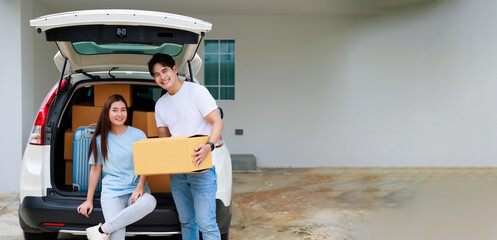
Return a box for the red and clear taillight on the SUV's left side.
[29,78,66,145]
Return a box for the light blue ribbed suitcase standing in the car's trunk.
[72,125,102,192]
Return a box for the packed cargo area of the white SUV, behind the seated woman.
[52,79,175,196]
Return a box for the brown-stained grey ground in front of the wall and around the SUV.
[0,168,497,240]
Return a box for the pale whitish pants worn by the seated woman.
[102,193,157,240]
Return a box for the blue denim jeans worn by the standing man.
[169,168,221,240]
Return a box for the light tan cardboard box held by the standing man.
[133,135,212,175]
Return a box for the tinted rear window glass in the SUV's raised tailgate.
[72,42,183,57]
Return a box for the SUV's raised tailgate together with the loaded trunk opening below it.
[30,10,212,197]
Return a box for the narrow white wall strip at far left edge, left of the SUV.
[0,1,22,191]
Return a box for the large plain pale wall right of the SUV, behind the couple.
[201,0,497,167]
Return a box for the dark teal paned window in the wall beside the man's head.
[204,40,235,100]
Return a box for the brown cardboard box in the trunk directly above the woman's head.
[93,84,132,107]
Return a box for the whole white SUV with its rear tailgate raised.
[19,10,232,239]
